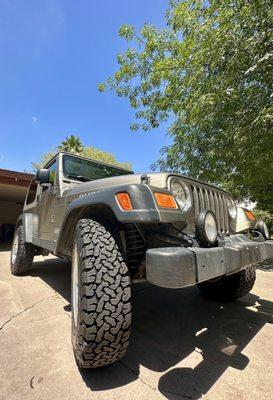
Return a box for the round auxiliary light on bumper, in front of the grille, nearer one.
[196,210,218,245]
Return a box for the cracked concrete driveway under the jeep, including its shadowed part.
[0,252,273,400]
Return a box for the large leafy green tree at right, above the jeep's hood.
[99,0,273,211]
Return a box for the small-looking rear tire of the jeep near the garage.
[10,225,35,275]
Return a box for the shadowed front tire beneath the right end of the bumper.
[197,265,256,301]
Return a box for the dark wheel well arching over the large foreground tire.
[56,204,119,256]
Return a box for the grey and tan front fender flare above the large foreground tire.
[56,184,186,254]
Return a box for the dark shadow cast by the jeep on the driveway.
[29,259,273,400]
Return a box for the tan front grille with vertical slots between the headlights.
[191,185,229,233]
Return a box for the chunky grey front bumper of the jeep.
[146,234,273,288]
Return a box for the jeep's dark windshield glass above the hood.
[63,156,133,181]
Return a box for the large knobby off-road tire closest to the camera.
[71,219,131,368]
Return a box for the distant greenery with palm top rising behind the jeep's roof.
[32,135,132,171]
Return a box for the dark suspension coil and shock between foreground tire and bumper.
[125,225,146,274]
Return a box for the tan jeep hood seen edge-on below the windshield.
[67,173,170,195]
